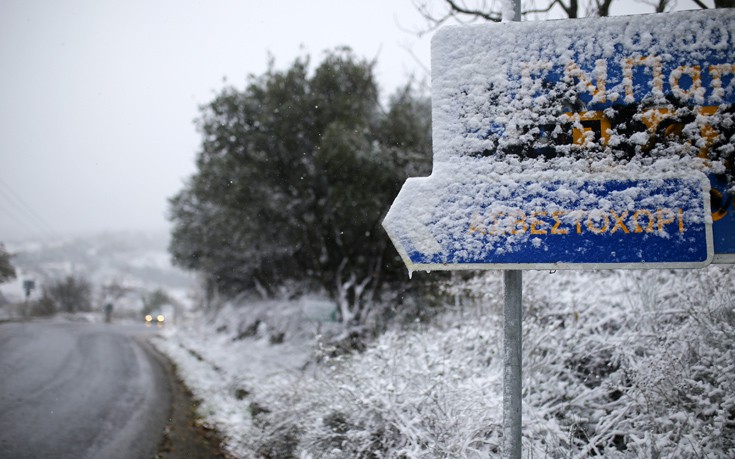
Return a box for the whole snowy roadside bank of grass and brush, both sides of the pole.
[155,266,735,458]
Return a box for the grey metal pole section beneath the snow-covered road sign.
[503,270,523,459]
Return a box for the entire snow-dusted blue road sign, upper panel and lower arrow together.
[383,9,735,270]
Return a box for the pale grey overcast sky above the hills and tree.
[0,0,708,242]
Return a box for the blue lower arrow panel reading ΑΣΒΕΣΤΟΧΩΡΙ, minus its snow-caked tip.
[392,178,712,270]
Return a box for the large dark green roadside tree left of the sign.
[170,49,431,322]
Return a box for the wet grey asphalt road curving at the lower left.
[0,322,171,459]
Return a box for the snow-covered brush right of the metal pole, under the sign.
[524,268,735,458]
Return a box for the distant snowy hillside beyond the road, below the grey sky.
[0,232,198,317]
